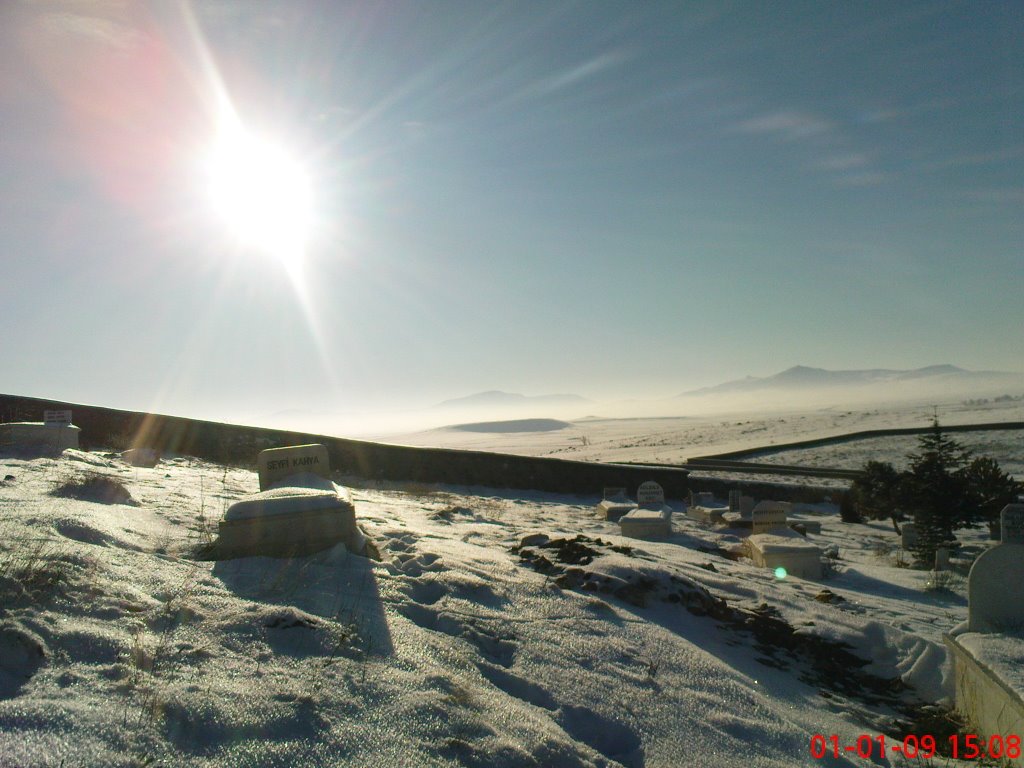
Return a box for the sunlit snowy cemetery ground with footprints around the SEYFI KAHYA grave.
[0,451,982,768]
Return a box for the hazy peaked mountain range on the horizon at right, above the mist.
[678,364,1020,397]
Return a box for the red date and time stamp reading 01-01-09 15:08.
[811,733,1022,760]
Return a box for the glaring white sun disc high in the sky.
[201,124,313,265]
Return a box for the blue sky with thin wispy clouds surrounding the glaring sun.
[0,0,1024,428]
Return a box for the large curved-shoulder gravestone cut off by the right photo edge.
[967,504,1024,632]
